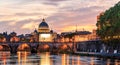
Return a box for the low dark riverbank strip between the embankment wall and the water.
[74,52,120,59]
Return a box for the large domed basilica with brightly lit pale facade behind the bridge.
[31,19,57,42]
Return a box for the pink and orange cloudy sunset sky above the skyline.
[0,0,119,34]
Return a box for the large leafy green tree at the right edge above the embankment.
[96,2,120,44]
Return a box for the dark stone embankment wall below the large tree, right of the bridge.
[76,42,120,53]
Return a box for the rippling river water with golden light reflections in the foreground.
[0,52,120,65]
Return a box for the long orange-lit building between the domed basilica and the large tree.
[57,30,99,42]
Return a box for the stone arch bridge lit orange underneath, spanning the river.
[0,42,74,53]
